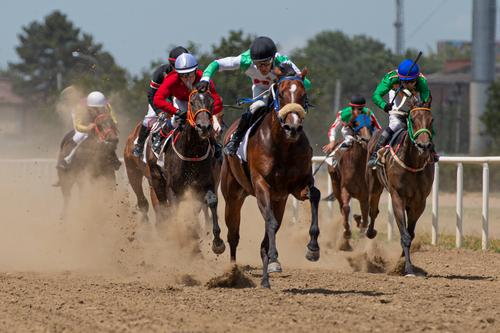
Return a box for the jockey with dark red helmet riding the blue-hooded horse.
[323,95,381,154]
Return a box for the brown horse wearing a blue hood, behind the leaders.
[328,114,373,251]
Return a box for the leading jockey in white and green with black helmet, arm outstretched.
[197,37,311,155]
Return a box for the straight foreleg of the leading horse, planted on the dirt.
[255,177,279,288]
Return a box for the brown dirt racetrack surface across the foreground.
[0,245,500,332]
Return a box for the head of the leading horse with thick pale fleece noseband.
[273,63,307,141]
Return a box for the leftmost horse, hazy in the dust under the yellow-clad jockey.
[57,112,118,217]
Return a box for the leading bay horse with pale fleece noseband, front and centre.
[221,64,321,288]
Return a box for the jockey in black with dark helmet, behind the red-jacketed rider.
[133,46,189,157]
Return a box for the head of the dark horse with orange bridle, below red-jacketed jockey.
[187,90,214,139]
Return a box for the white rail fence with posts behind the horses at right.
[312,156,500,250]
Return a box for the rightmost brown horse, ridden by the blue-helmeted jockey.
[366,98,434,276]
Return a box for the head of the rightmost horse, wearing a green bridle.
[407,99,434,153]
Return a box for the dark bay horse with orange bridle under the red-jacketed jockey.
[146,90,225,254]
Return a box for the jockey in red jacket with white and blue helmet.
[153,53,222,154]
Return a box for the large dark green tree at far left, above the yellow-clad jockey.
[9,11,127,102]
